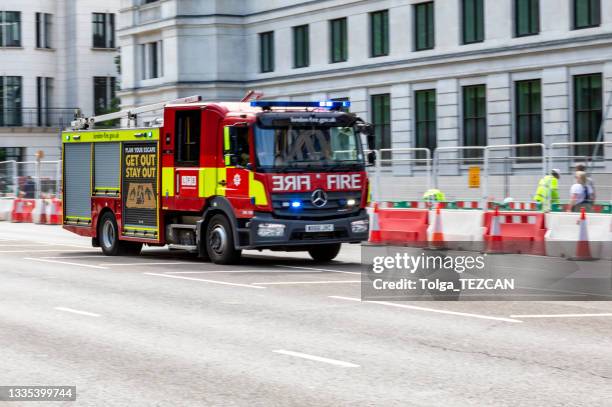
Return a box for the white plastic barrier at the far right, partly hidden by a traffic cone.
[546,212,612,260]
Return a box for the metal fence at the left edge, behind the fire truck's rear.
[0,161,62,199]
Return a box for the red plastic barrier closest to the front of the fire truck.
[371,208,429,245]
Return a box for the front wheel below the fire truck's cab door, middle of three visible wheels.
[206,215,241,264]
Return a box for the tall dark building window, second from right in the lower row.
[516,79,542,156]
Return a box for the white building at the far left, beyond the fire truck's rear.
[0,0,119,162]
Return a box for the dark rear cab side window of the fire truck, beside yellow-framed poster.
[174,110,201,166]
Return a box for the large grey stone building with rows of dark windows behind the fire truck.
[119,0,612,178]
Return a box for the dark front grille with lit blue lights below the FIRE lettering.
[272,191,361,220]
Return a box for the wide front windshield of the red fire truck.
[254,126,364,172]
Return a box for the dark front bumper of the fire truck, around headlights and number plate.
[242,210,369,249]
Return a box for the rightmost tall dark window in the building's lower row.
[574,74,603,156]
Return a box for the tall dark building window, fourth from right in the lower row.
[414,89,437,159]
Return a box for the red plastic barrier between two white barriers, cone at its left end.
[484,211,546,256]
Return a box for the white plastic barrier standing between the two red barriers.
[427,209,485,242]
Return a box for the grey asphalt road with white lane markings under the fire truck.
[0,222,612,406]
